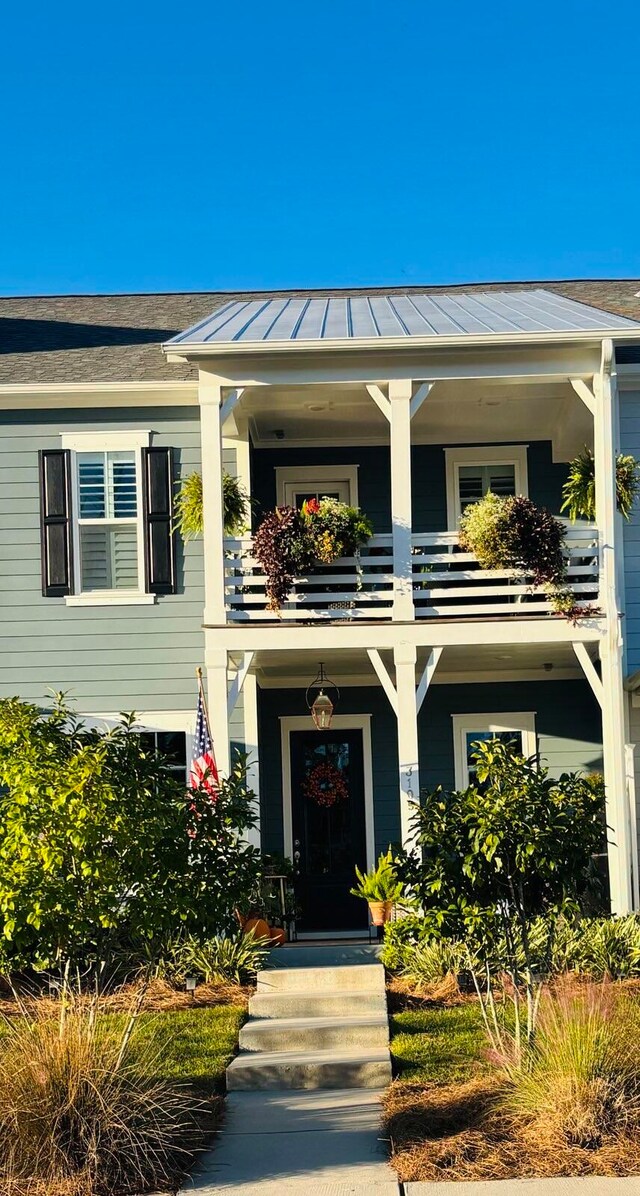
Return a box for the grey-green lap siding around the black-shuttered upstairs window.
[0,407,205,713]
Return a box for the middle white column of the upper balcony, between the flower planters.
[389,378,415,622]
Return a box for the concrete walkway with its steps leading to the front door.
[183,946,398,1196]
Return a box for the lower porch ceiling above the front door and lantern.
[251,643,597,688]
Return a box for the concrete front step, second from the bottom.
[240,1012,389,1051]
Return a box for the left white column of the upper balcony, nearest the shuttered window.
[199,370,225,626]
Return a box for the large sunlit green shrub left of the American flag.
[0,698,260,970]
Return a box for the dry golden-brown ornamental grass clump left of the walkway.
[0,994,202,1196]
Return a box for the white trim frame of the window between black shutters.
[60,429,156,606]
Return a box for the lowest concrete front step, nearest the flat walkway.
[226,1048,391,1092]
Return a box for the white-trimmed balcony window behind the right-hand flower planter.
[445,445,529,531]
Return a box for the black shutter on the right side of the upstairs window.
[142,449,176,594]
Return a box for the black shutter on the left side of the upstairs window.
[39,449,73,598]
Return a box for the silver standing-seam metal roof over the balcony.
[166,288,640,350]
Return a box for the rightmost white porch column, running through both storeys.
[593,340,635,914]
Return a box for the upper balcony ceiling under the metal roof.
[242,379,592,453]
